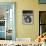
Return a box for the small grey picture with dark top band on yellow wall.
[22,10,33,24]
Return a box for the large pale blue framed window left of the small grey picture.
[0,2,16,40]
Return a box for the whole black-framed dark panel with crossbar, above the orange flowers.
[39,11,46,35]
